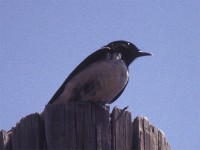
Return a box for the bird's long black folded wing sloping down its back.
[48,47,108,104]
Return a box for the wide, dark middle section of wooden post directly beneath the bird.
[44,102,111,150]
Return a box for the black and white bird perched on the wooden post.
[48,41,152,105]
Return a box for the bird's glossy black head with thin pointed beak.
[105,41,152,66]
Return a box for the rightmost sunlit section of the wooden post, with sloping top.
[133,116,171,150]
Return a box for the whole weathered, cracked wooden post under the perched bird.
[0,102,170,150]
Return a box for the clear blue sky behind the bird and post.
[0,0,200,150]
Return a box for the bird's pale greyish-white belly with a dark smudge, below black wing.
[56,59,128,103]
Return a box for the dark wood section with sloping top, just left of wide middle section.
[12,113,44,150]
